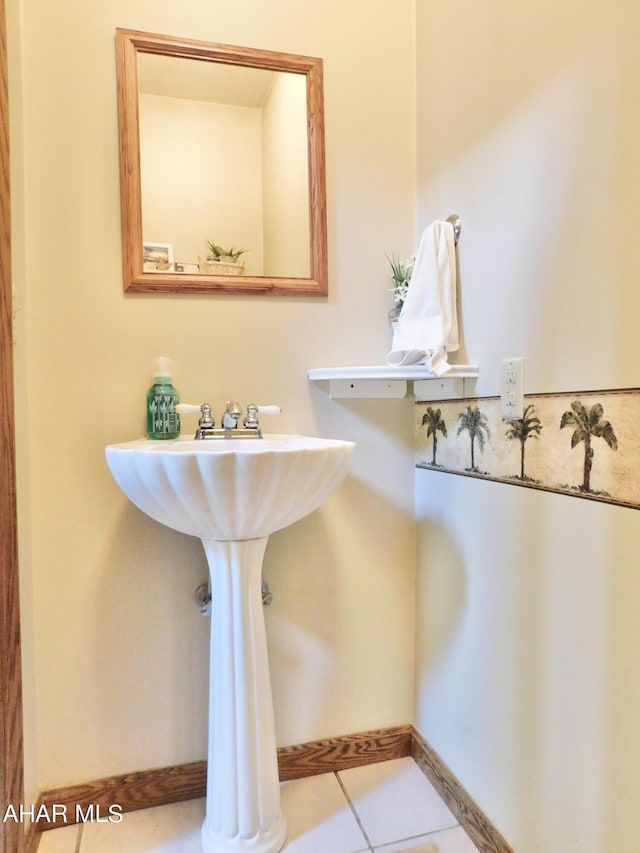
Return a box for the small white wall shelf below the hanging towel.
[307,364,478,400]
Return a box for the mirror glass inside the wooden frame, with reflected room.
[138,53,311,278]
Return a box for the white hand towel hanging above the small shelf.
[387,220,458,376]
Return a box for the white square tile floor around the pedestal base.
[38,758,477,853]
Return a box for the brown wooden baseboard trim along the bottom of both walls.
[30,725,514,853]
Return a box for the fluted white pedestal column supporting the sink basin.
[201,536,287,853]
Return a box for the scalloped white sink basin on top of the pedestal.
[106,435,354,540]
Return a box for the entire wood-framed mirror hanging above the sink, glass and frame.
[116,29,328,296]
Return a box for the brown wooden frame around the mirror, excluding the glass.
[116,29,328,296]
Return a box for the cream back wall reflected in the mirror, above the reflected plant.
[138,93,263,275]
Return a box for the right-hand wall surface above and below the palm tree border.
[416,0,640,853]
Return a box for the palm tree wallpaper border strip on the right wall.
[416,388,640,509]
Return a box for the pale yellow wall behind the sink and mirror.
[10,0,415,791]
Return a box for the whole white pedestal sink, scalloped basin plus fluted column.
[106,435,355,853]
